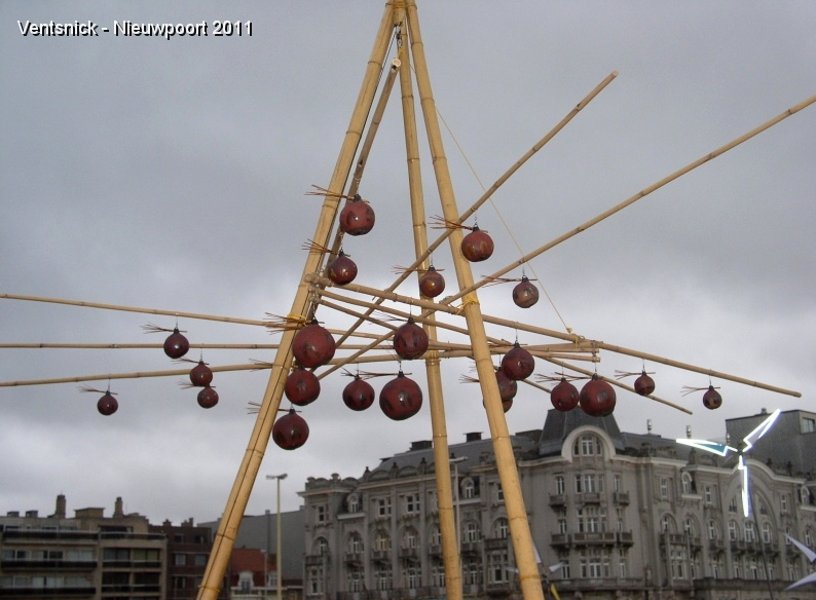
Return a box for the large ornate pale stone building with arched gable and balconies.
[302,410,816,600]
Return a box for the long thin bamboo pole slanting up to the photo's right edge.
[450,95,816,304]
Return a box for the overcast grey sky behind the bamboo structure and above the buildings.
[0,0,816,522]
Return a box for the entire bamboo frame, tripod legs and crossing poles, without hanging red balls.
[0,0,816,600]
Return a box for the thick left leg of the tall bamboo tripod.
[198,2,400,600]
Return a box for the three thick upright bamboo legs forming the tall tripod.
[198,0,544,600]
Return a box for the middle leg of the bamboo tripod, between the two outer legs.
[398,11,463,600]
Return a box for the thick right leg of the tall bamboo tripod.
[406,0,544,600]
